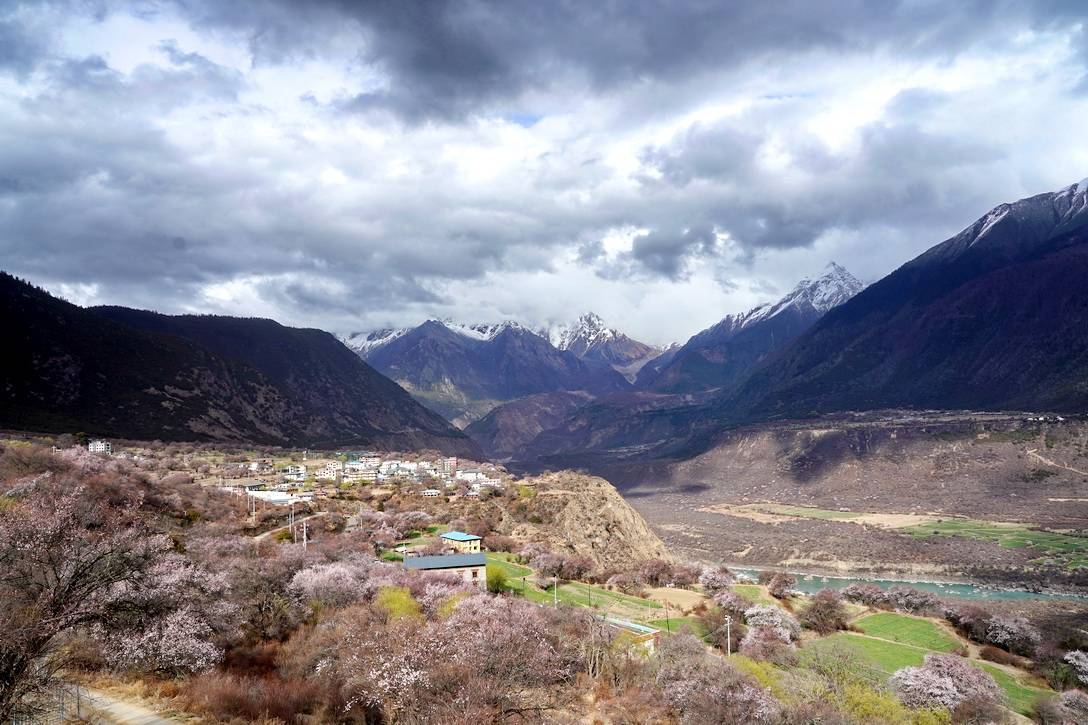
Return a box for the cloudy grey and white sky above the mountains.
[0,0,1088,343]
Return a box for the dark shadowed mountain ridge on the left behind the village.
[0,273,480,457]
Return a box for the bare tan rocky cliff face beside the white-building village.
[507,471,672,569]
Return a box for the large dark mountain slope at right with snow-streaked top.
[730,183,1088,419]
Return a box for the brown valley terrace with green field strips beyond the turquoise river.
[613,413,1088,587]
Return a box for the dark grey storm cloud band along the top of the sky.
[165,0,1088,120]
